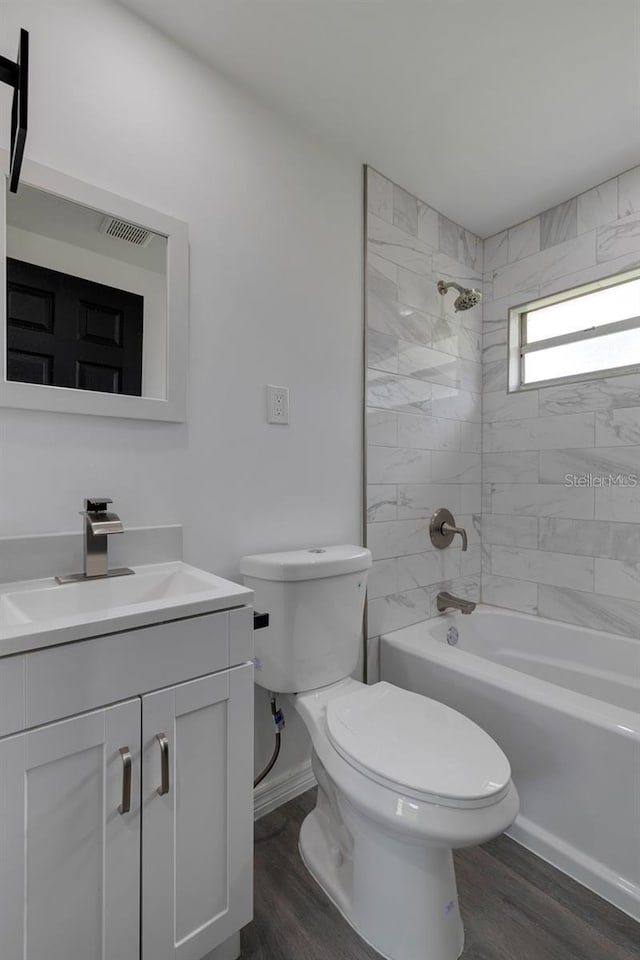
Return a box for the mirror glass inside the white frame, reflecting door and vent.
[6,185,167,400]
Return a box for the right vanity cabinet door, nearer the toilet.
[142,664,253,960]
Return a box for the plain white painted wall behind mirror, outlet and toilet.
[0,0,362,774]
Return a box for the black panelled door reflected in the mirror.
[7,258,144,397]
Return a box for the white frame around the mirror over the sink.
[0,150,189,422]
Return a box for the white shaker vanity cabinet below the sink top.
[0,607,253,960]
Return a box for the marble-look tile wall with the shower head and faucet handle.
[366,168,480,660]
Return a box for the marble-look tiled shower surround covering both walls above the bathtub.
[366,167,640,638]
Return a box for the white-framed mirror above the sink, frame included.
[0,152,188,420]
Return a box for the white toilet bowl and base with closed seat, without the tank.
[291,680,518,960]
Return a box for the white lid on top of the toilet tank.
[240,544,371,581]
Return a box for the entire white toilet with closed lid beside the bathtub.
[240,545,518,960]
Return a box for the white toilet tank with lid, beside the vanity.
[240,545,371,693]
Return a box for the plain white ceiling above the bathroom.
[120,0,640,237]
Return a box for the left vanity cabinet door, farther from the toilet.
[0,700,140,960]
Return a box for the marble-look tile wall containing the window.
[481,167,640,638]
